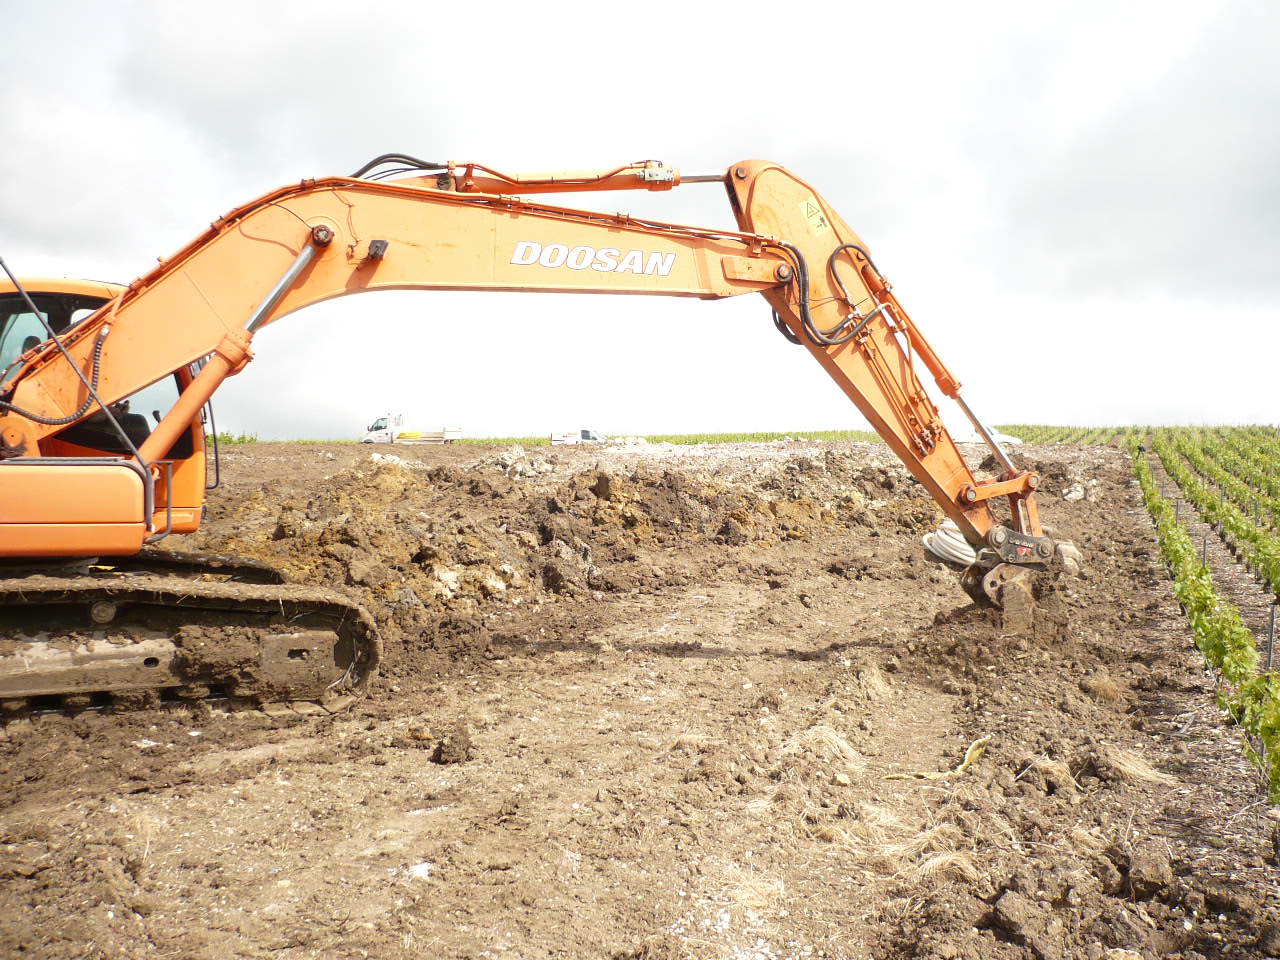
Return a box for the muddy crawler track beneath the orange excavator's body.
[0,575,380,716]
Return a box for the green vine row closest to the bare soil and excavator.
[1129,438,1280,804]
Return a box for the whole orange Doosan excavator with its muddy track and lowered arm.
[0,154,1059,710]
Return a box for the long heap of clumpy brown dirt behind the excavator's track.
[214,447,901,676]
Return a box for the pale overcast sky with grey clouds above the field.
[0,0,1280,438]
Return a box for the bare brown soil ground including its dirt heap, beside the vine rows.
[0,443,1280,960]
